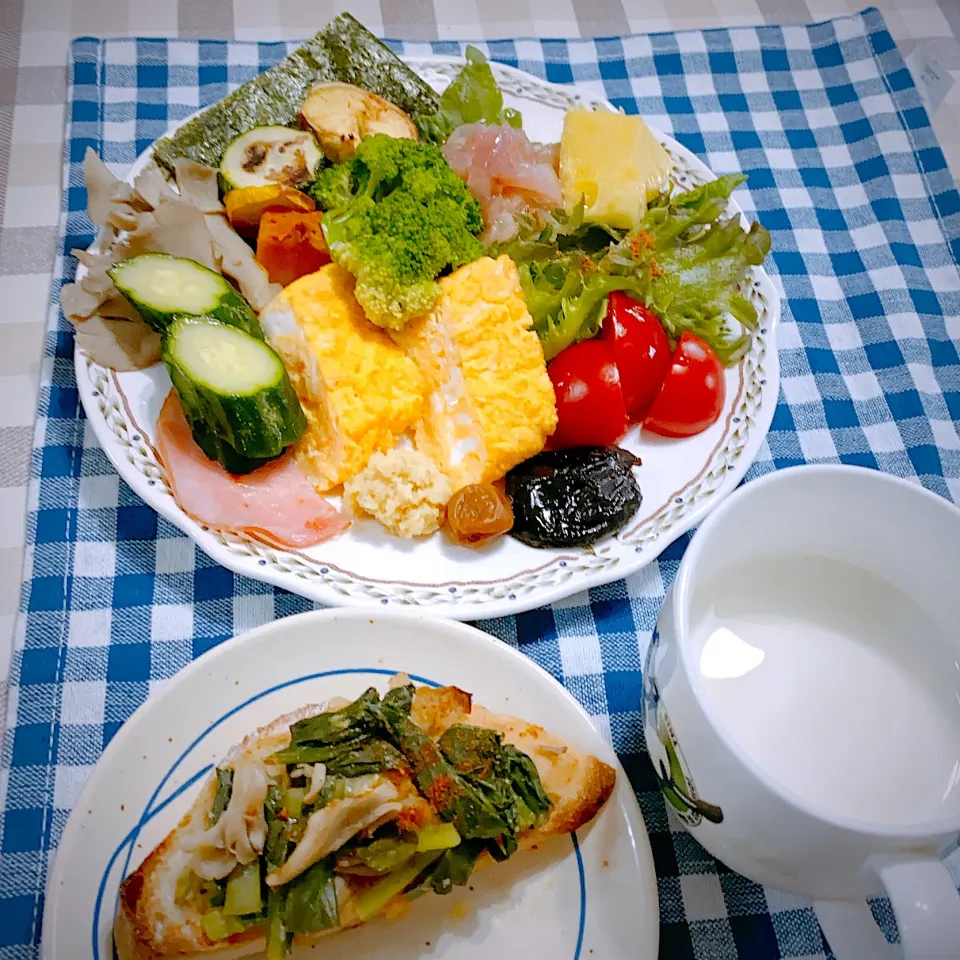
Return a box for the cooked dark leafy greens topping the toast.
[178,685,551,960]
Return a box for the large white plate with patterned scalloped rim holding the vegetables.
[75,57,780,620]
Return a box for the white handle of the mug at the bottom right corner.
[813,855,960,960]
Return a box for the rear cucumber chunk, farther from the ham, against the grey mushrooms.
[108,253,263,340]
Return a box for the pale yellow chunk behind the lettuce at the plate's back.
[560,109,671,230]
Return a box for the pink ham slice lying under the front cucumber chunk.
[157,390,350,547]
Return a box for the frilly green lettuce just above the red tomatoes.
[493,174,770,365]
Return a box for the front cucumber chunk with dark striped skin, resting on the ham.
[163,317,307,473]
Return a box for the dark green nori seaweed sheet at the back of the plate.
[153,13,440,170]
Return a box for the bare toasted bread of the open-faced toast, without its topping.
[114,687,616,960]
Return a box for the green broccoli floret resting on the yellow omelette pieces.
[310,134,483,330]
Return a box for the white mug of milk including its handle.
[643,465,960,960]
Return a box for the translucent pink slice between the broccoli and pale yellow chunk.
[443,123,563,244]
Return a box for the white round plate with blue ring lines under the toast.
[41,610,659,960]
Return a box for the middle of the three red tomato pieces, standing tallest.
[600,290,670,414]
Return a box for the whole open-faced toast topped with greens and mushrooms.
[114,679,615,960]
